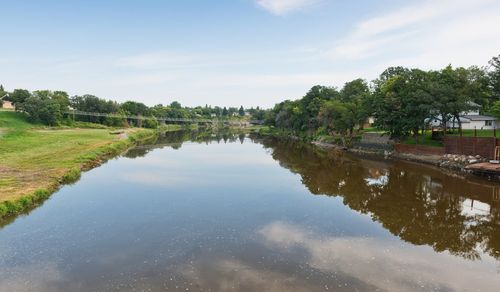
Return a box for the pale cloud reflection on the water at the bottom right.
[259,221,500,291]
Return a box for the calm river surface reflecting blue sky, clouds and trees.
[0,132,500,292]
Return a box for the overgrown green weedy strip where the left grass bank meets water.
[0,129,161,221]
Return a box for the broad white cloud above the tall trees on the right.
[326,0,500,68]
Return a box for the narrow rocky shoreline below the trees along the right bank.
[254,130,480,177]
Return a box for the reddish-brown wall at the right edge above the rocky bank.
[444,136,497,159]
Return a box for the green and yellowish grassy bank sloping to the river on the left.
[0,111,180,218]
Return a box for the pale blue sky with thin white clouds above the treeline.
[0,0,500,108]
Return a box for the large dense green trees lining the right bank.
[266,55,500,138]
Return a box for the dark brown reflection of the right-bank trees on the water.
[259,138,500,260]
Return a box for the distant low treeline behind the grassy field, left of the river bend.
[0,85,264,128]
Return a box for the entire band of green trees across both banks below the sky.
[0,55,500,138]
